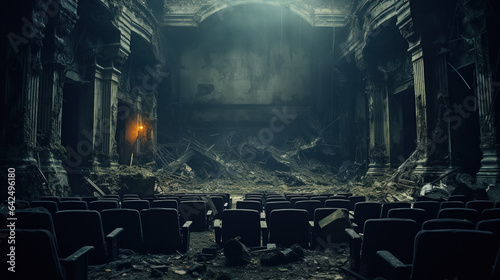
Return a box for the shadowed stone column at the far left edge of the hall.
[0,4,47,200]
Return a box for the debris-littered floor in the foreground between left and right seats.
[89,231,355,280]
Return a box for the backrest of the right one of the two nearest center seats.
[269,209,311,248]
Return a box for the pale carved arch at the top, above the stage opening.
[162,0,355,27]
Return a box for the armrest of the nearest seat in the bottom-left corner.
[60,246,94,280]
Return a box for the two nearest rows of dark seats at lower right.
[346,218,500,280]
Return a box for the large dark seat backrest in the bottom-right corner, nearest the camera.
[411,229,498,280]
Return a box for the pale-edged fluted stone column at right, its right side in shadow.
[397,1,449,180]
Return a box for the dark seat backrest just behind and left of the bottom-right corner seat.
[360,218,420,277]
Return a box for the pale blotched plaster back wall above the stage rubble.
[179,5,314,121]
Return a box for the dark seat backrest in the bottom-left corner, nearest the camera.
[0,229,64,280]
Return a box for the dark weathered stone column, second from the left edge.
[37,1,77,196]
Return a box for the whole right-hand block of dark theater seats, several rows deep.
[346,197,500,280]
